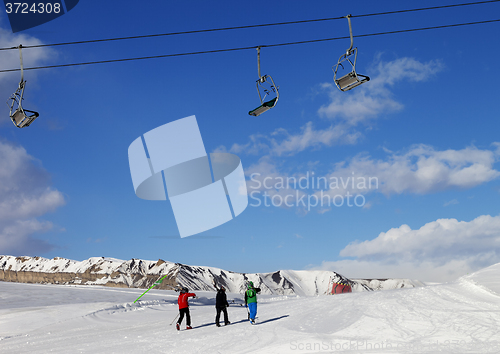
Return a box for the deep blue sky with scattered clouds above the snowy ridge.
[0,0,500,281]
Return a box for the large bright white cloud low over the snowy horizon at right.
[314,215,500,281]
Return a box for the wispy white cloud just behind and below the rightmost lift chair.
[318,58,443,125]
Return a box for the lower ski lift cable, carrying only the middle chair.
[0,18,500,73]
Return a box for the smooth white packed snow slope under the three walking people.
[0,264,500,354]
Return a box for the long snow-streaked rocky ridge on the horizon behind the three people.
[0,256,423,296]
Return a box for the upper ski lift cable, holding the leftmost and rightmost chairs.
[0,0,500,51]
